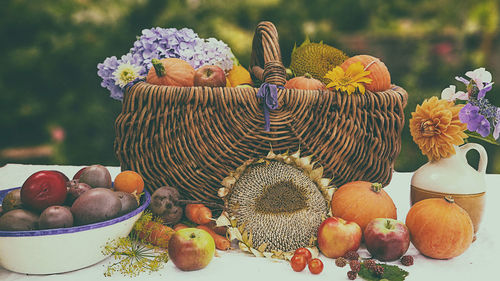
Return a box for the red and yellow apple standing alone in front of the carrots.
[168,228,215,271]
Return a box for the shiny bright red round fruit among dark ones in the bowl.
[21,171,67,211]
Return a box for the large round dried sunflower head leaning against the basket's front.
[219,152,333,257]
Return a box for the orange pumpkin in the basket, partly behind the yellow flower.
[341,55,391,92]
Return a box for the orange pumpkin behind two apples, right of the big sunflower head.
[331,181,397,232]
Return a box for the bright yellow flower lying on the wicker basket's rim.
[325,62,372,95]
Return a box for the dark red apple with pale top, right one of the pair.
[364,218,410,261]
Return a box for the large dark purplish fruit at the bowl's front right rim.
[71,187,122,225]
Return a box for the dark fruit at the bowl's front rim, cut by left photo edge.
[0,209,39,231]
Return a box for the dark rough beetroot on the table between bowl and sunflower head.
[149,186,183,224]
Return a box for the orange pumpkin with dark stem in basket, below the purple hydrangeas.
[146,58,195,87]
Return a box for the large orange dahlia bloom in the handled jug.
[410,97,467,161]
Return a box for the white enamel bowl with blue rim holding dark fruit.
[0,188,151,274]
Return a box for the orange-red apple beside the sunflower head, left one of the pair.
[318,217,362,258]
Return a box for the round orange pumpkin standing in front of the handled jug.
[406,197,474,259]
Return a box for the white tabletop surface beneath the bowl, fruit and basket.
[0,164,500,281]
